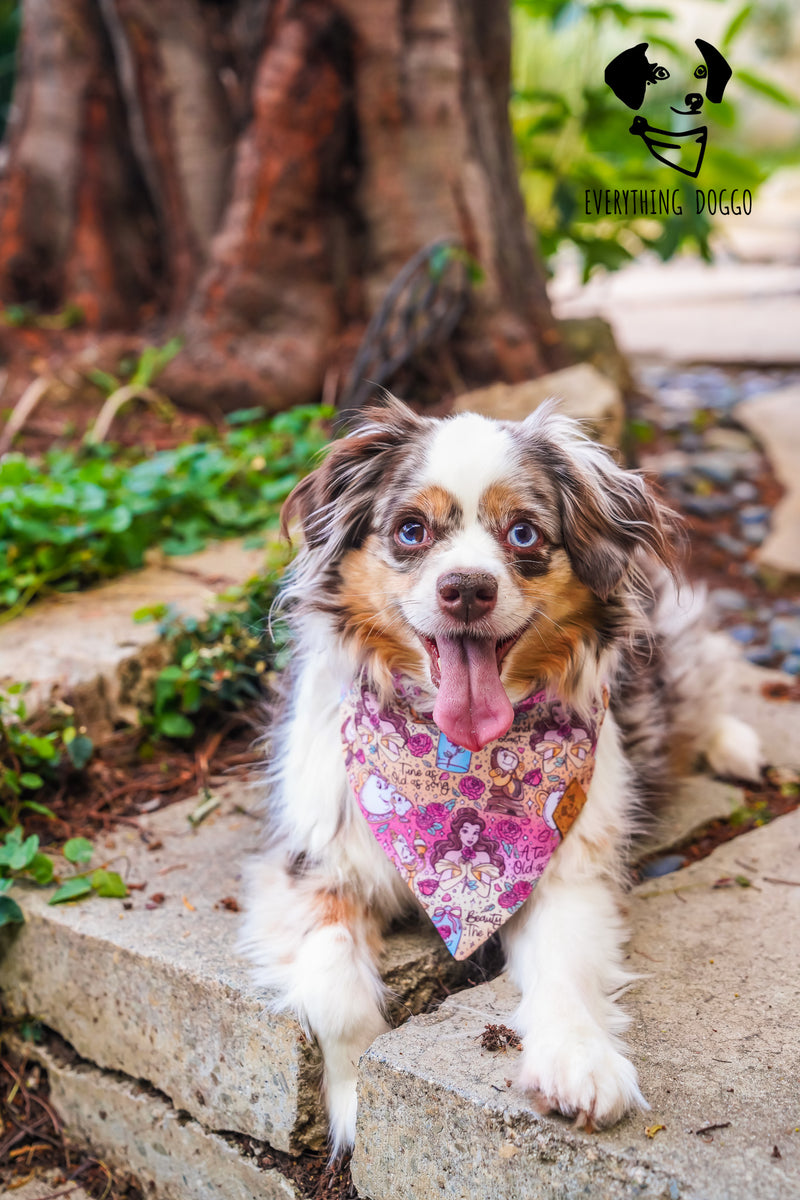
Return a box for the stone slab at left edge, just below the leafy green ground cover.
[0,540,272,732]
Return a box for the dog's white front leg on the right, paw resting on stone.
[504,714,646,1126]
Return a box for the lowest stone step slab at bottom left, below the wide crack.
[10,1043,300,1200]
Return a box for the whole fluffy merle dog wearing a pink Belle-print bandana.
[241,397,759,1152]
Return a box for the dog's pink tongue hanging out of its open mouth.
[433,637,513,750]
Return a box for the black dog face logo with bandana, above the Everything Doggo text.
[604,37,733,179]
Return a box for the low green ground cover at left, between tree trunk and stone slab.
[0,407,331,622]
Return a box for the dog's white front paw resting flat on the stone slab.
[518,1028,649,1129]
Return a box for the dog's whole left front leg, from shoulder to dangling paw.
[240,623,409,1151]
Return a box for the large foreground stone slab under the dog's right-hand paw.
[353,812,800,1200]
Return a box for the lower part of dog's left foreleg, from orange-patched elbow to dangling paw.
[242,858,389,1153]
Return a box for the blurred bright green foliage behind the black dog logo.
[510,0,798,278]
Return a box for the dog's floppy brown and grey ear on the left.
[281,392,428,558]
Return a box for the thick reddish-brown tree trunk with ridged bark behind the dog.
[0,0,565,408]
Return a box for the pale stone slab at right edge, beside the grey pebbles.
[734,386,800,578]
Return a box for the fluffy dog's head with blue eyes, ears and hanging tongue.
[284,400,674,749]
